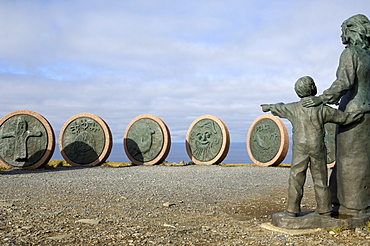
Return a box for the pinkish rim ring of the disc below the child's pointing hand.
[247,114,289,166]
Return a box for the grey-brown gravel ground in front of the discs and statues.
[0,165,370,245]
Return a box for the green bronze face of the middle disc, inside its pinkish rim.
[126,118,164,163]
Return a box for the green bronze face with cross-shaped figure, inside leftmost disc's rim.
[0,114,48,167]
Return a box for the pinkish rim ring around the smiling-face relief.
[185,115,230,165]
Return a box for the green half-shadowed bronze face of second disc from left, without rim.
[62,117,107,165]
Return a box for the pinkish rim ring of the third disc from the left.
[123,114,171,165]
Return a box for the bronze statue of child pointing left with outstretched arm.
[261,76,363,217]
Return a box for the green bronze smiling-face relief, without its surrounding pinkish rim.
[189,119,223,162]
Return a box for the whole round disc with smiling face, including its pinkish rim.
[186,115,230,165]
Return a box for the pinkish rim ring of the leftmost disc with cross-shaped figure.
[0,110,55,169]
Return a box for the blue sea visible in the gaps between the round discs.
[52,142,292,164]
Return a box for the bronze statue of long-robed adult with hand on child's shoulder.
[303,14,370,215]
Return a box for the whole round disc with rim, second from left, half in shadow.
[59,113,112,166]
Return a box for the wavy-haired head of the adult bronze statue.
[341,14,370,50]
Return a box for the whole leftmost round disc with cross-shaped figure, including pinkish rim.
[0,110,55,168]
